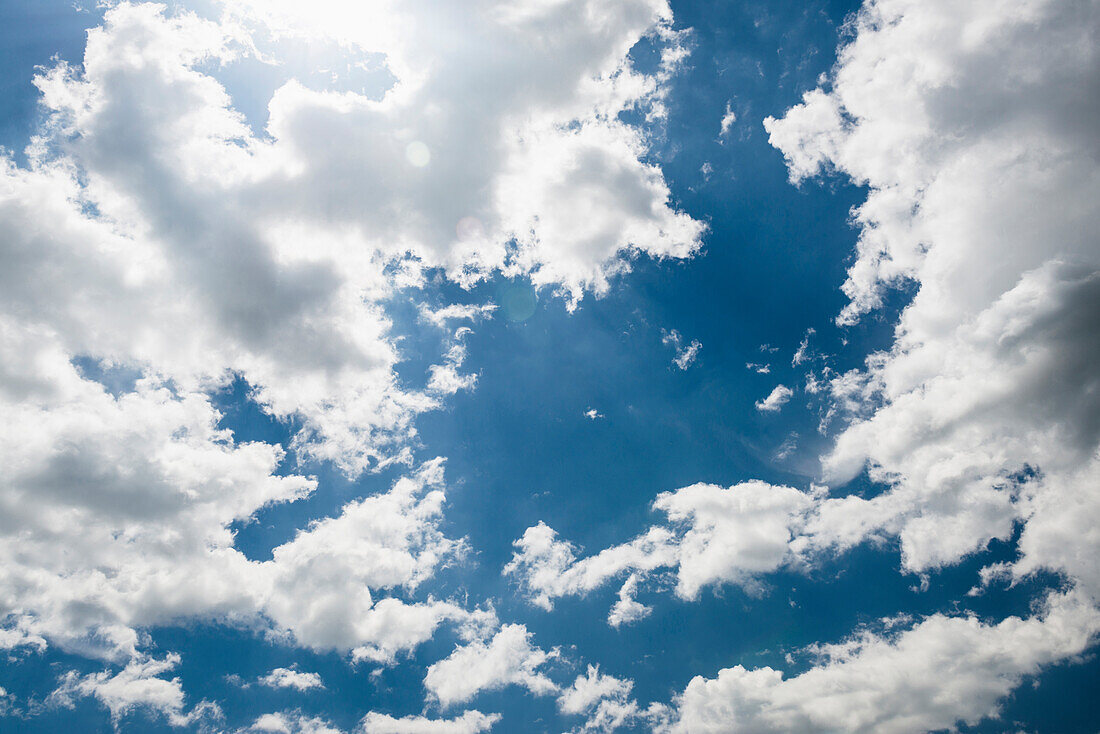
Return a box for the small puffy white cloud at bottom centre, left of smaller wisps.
[424,624,558,706]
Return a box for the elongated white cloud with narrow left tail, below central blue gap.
[504,481,814,626]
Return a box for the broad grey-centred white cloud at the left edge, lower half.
[0,358,316,655]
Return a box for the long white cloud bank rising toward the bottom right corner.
[662,594,1100,734]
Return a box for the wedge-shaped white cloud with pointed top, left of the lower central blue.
[261,459,495,664]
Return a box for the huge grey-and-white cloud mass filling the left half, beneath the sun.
[0,0,703,686]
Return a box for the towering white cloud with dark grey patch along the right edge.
[766,1,1100,592]
